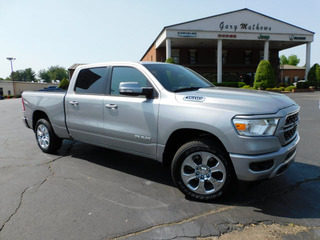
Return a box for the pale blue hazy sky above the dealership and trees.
[0,0,320,78]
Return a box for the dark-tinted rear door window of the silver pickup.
[74,67,107,94]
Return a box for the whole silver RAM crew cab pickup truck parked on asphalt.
[22,62,300,200]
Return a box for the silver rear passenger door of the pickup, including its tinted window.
[65,67,108,145]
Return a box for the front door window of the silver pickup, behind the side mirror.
[110,67,151,95]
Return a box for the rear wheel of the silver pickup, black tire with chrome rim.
[34,119,62,153]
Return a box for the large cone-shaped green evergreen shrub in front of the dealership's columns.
[253,60,276,89]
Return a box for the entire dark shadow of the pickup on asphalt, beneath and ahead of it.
[59,142,320,219]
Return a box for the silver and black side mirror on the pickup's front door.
[119,82,153,98]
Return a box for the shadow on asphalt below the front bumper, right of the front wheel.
[211,162,320,219]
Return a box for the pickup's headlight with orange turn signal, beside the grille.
[233,118,279,136]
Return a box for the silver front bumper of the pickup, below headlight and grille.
[230,132,300,181]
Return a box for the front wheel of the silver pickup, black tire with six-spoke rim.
[171,139,235,201]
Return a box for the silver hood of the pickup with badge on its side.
[176,87,296,114]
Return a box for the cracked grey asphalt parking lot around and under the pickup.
[0,92,320,240]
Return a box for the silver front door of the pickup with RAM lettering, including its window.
[104,66,159,157]
